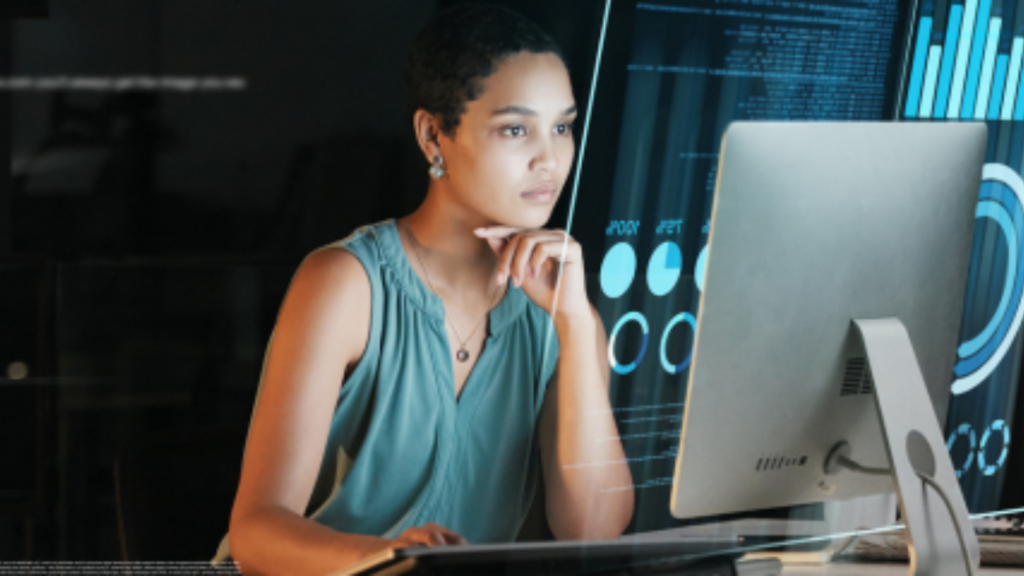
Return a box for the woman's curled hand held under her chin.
[475,227,591,319]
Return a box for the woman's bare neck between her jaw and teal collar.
[398,190,498,297]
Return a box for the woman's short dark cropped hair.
[406,4,565,137]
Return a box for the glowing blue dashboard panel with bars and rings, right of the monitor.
[900,0,1024,512]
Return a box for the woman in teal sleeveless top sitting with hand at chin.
[218,5,633,574]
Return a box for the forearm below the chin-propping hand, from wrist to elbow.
[540,306,633,539]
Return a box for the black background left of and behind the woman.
[0,0,604,561]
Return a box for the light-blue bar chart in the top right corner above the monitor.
[902,0,1024,121]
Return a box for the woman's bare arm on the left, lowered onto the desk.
[228,249,458,575]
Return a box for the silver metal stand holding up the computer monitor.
[826,318,981,576]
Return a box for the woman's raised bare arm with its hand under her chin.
[475,225,633,539]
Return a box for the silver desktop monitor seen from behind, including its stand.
[671,122,987,573]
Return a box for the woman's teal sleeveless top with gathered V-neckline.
[213,215,558,564]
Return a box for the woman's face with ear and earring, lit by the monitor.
[438,52,577,228]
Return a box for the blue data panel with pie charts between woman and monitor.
[571,0,910,531]
